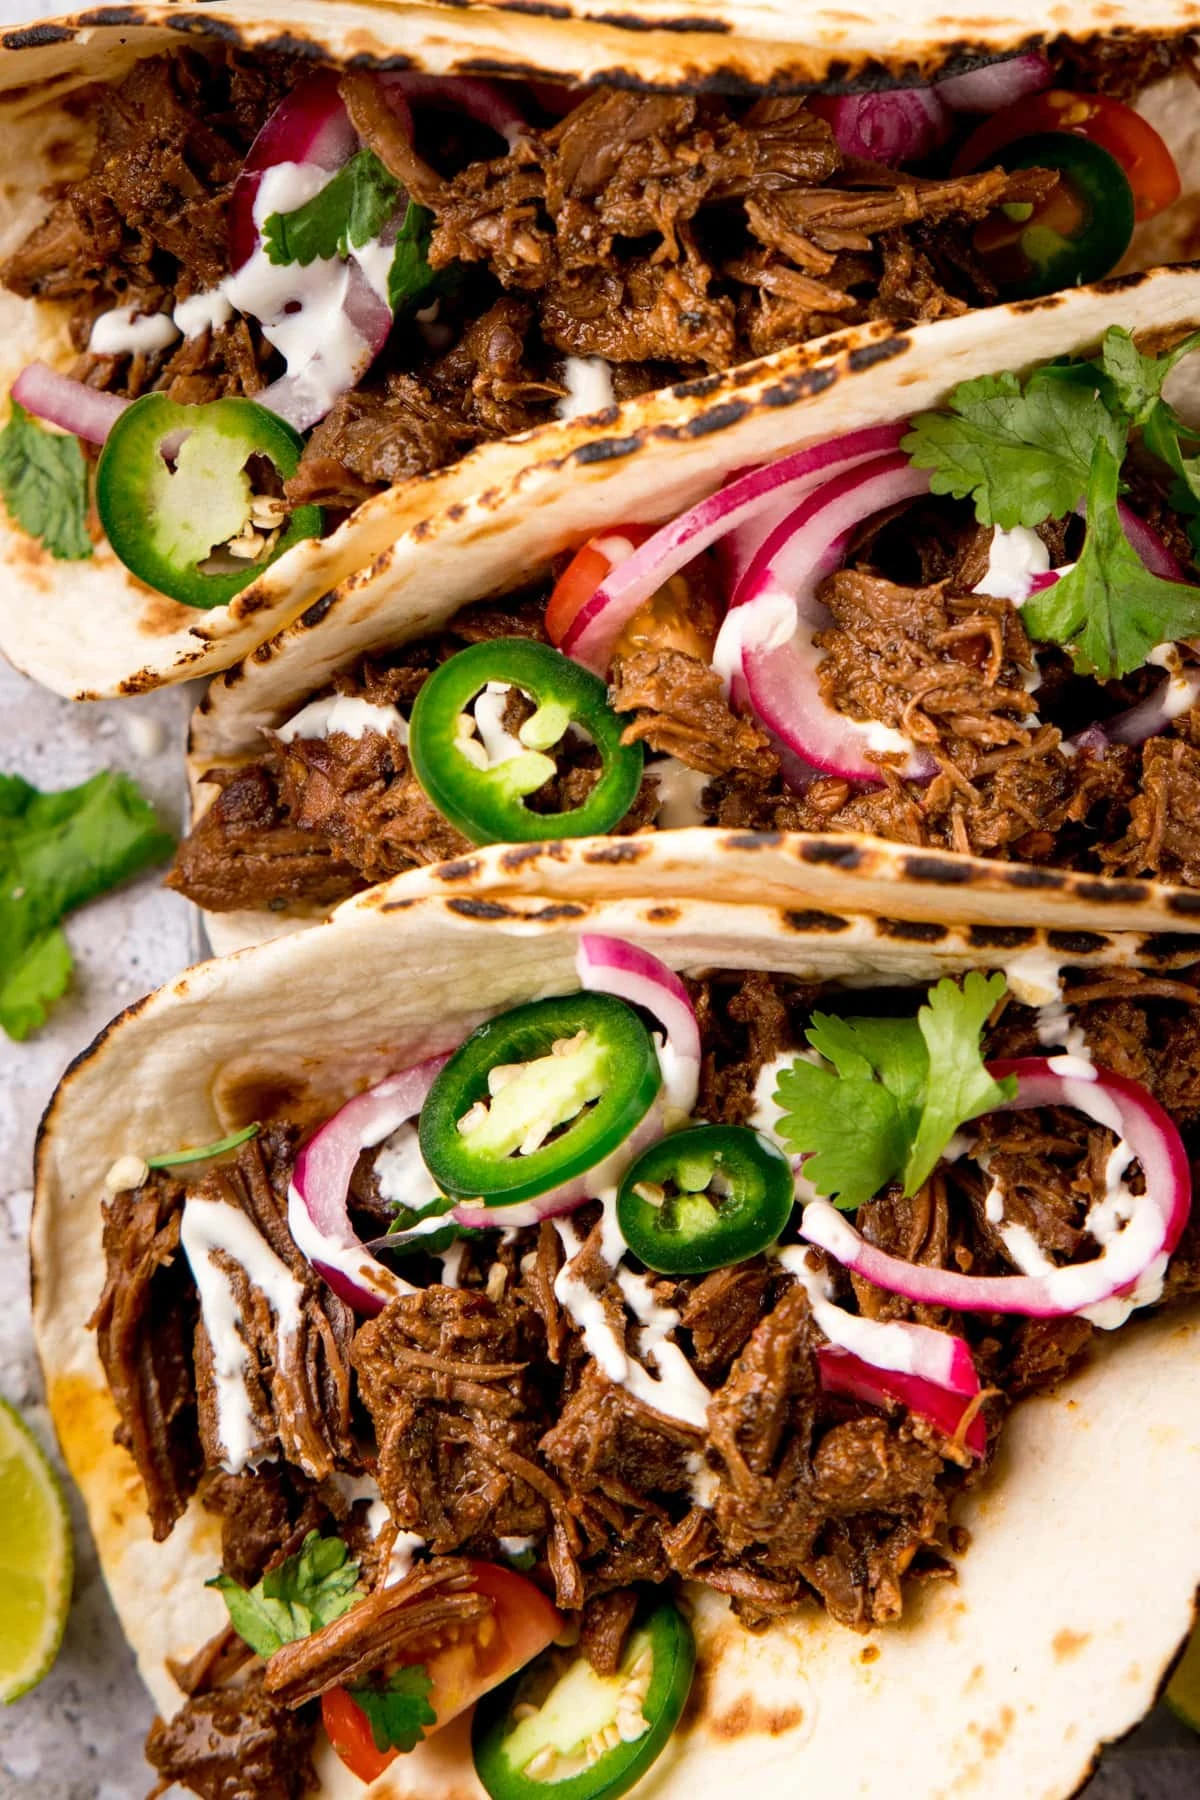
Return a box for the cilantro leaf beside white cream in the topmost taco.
[263,149,437,313]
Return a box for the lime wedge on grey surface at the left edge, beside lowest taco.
[0,1400,74,1701]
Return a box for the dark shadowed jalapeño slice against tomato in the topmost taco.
[973,131,1133,299]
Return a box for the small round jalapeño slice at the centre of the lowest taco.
[617,1125,795,1274]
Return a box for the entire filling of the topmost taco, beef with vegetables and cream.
[2,40,1186,608]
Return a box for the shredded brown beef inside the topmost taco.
[2,47,1086,513]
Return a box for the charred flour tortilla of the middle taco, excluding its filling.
[189,262,1200,950]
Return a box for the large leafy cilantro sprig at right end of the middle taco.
[903,326,1200,680]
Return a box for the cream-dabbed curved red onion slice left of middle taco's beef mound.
[712,452,936,783]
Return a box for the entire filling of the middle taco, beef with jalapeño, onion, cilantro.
[171,326,1200,911]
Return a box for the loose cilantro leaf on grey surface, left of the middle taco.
[0,770,173,1039]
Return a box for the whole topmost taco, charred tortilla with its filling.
[0,0,1195,697]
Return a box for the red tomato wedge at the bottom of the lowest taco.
[320,1562,563,1782]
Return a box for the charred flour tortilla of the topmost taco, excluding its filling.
[0,0,1200,698]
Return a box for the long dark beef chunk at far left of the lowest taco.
[88,1174,201,1539]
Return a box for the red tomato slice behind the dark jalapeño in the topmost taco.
[954,88,1180,221]
